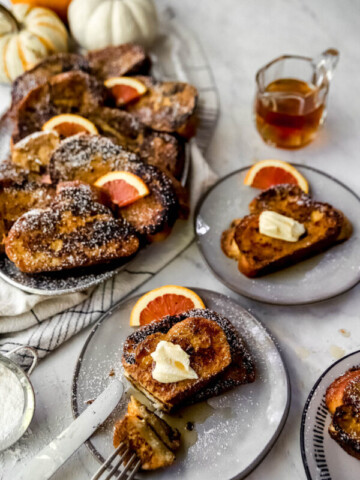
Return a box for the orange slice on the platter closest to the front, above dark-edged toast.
[95,172,150,207]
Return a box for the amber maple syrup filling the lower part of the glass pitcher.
[255,78,325,148]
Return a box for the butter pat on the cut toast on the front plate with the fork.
[151,340,198,383]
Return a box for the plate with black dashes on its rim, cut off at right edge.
[301,350,360,480]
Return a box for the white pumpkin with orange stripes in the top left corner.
[0,3,68,83]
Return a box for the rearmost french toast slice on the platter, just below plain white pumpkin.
[86,43,151,80]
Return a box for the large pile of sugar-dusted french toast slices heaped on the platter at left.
[0,44,198,274]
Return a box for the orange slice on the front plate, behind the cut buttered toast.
[130,285,205,327]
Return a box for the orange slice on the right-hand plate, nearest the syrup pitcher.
[244,160,309,193]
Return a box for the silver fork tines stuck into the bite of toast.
[91,443,141,480]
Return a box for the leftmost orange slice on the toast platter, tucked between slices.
[42,113,99,137]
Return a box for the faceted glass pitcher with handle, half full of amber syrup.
[254,48,339,148]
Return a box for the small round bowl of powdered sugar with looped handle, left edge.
[0,347,38,452]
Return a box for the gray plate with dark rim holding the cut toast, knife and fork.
[72,289,290,480]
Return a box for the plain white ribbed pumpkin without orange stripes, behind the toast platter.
[68,0,158,50]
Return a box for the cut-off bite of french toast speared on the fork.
[113,396,180,470]
